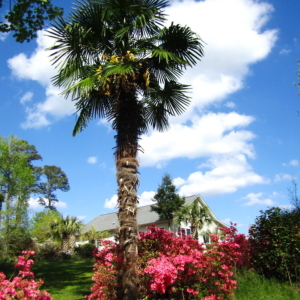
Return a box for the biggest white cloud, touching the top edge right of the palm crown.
[166,0,277,119]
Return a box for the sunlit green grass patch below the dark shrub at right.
[234,270,300,300]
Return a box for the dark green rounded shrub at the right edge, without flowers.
[249,207,300,283]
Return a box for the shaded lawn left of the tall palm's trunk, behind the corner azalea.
[0,259,94,300]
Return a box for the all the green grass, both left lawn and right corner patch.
[0,259,300,300]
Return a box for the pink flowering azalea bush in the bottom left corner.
[0,251,52,300]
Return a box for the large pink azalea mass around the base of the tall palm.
[87,226,249,300]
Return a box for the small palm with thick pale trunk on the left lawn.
[51,216,83,254]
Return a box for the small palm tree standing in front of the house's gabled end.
[175,201,212,239]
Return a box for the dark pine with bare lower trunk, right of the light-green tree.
[35,166,70,210]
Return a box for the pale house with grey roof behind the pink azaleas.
[83,195,227,243]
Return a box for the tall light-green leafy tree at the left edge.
[0,136,41,255]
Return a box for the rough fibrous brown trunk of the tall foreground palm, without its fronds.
[115,86,141,300]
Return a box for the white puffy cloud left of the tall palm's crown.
[8,31,75,129]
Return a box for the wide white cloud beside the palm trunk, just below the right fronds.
[140,112,255,166]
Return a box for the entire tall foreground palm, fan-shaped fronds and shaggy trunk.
[49,0,203,300]
